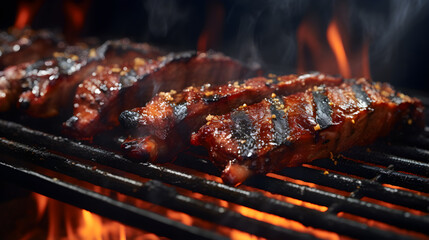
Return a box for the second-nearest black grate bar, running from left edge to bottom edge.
[0,139,314,239]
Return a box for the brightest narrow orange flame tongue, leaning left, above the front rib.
[326,20,351,78]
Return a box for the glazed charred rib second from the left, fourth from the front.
[18,40,158,118]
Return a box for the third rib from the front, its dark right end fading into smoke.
[64,52,248,138]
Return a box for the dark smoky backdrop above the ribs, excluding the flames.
[0,0,429,92]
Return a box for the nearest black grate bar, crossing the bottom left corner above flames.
[0,161,226,240]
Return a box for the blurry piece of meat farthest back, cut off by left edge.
[0,29,61,69]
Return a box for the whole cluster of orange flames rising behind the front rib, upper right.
[296,8,371,78]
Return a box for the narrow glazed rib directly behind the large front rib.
[120,74,342,162]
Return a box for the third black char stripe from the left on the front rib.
[313,87,333,130]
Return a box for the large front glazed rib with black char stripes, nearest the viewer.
[191,79,423,185]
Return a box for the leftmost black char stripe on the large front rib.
[231,111,257,158]
